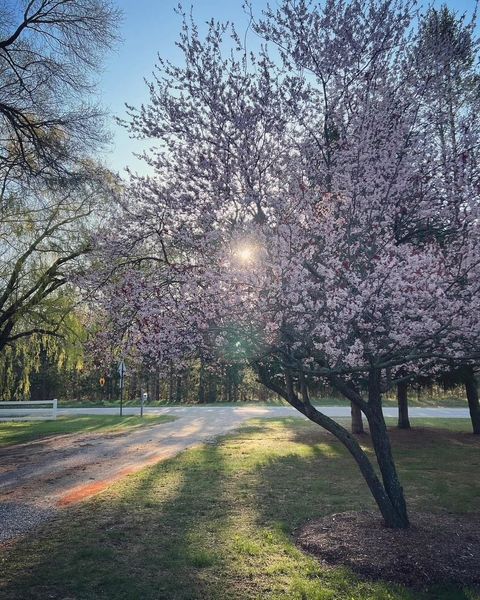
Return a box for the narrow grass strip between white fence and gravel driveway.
[0,415,175,448]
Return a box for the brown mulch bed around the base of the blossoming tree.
[296,512,480,588]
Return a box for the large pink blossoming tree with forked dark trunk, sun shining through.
[94,0,480,528]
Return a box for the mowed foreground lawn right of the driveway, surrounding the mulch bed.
[0,418,480,600]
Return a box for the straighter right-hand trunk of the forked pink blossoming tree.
[367,370,409,529]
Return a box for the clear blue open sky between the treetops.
[98,0,475,172]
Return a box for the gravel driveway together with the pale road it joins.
[0,406,468,542]
